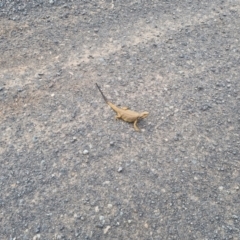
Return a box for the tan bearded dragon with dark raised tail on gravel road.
[96,83,149,131]
